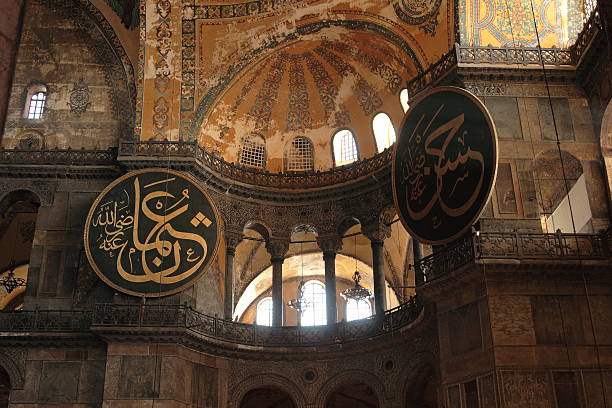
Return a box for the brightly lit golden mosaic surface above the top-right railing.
[459,0,584,48]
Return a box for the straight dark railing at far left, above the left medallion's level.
[0,148,117,166]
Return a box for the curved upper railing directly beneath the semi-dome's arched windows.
[119,141,392,188]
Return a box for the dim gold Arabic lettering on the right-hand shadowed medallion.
[401,105,485,229]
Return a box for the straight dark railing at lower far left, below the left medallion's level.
[0,310,92,332]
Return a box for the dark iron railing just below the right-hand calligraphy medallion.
[416,230,612,281]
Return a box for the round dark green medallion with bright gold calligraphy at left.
[85,169,221,297]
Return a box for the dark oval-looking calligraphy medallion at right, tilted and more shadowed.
[392,87,497,245]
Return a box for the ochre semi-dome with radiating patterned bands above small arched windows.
[198,27,416,172]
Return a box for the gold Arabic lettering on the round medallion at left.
[91,177,212,284]
